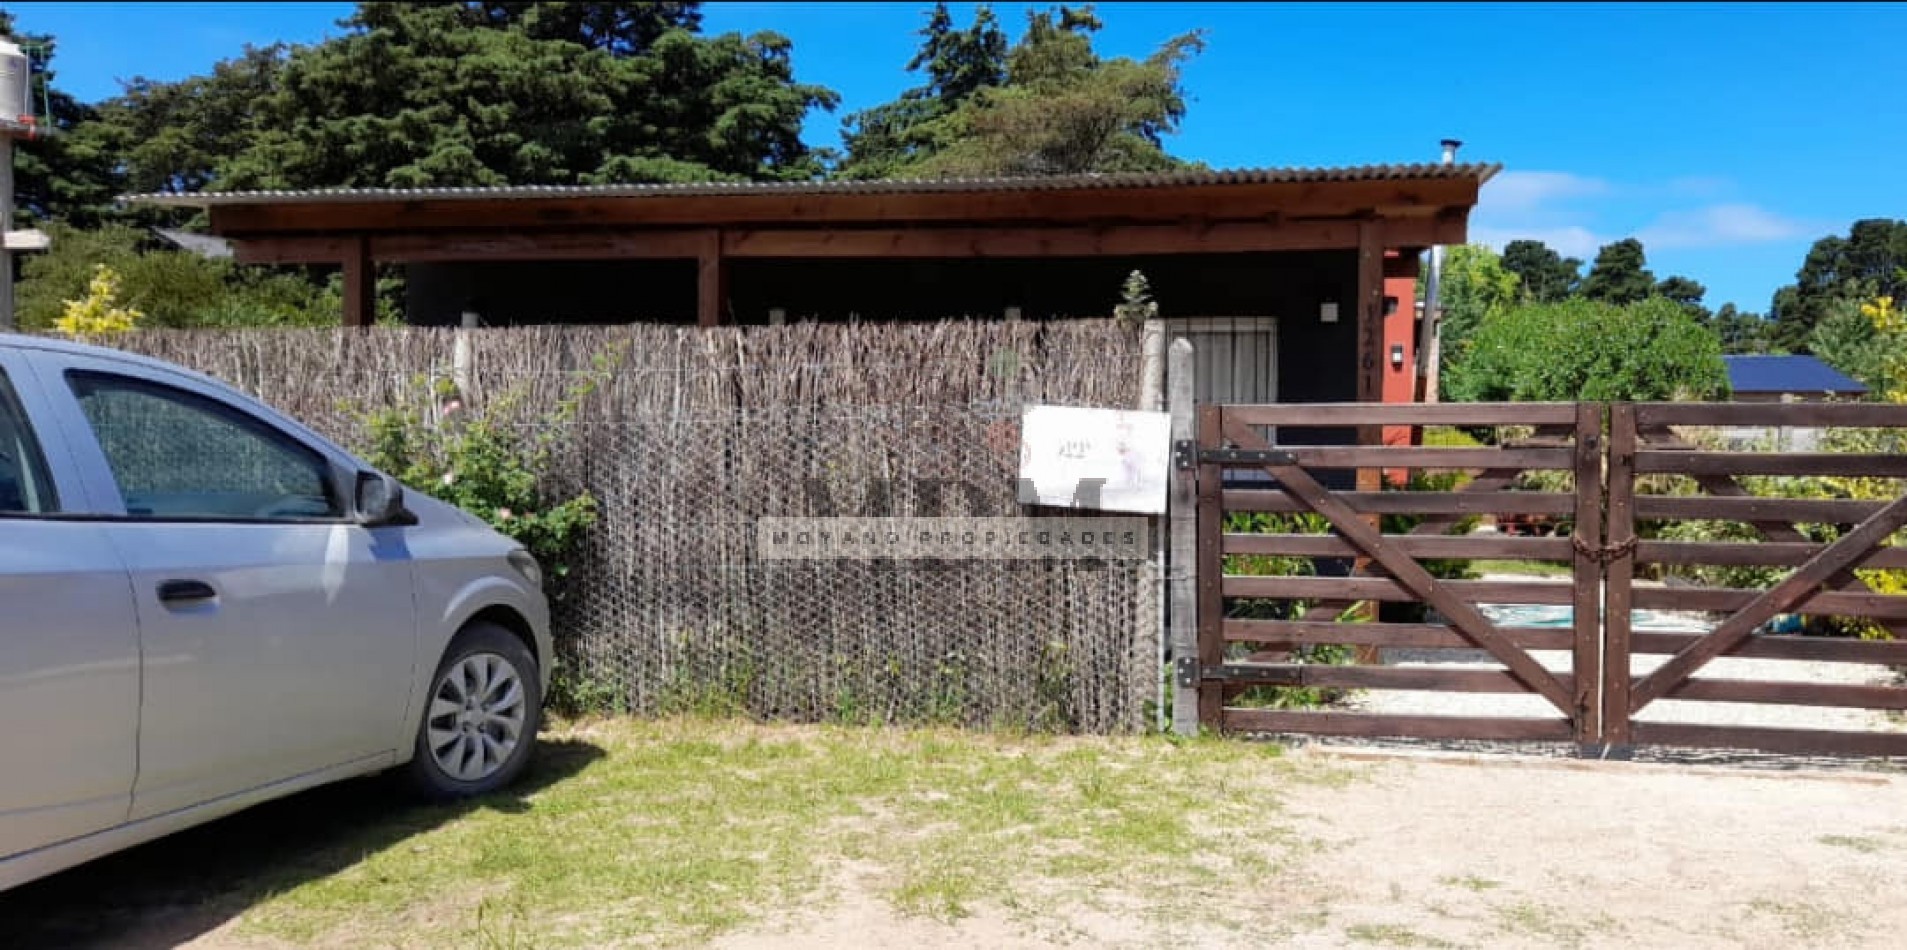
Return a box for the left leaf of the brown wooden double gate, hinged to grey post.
[1175,403,1602,742]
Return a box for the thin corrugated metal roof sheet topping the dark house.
[120,162,1503,208]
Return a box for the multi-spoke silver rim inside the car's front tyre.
[425,652,528,782]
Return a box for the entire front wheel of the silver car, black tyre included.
[406,622,543,801]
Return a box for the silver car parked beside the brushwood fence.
[0,336,551,889]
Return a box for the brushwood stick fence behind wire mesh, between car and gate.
[116,320,1159,733]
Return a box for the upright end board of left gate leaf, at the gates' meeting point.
[1569,403,1602,748]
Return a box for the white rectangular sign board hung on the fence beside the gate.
[1020,406,1173,515]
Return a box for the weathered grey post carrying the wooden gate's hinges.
[1165,340,1200,736]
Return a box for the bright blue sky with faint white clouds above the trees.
[8,2,1907,311]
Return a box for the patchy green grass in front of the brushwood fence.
[33,717,1346,948]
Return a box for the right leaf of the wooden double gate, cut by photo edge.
[1604,403,1907,755]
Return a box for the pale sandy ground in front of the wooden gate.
[701,752,1907,950]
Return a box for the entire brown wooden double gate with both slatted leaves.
[1173,394,1907,755]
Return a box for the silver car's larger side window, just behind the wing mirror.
[67,372,341,521]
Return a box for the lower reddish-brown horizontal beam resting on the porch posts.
[235,214,1465,263]
